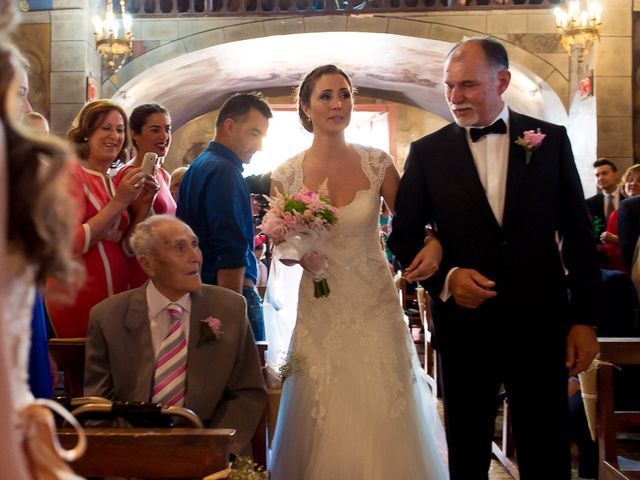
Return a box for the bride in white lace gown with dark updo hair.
[271,65,448,480]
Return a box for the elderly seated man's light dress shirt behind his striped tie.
[147,280,191,358]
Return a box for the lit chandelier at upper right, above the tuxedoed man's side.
[554,0,602,62]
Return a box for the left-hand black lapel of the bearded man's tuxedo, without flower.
[443,124,500,229]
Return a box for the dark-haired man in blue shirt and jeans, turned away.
[176,93,272,340]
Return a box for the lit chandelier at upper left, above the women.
[93,0,133,73]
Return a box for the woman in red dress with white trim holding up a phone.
[46,100,158,338]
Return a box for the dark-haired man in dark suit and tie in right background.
[586,158,627,233]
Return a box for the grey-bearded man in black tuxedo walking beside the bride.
[389,39,600,480]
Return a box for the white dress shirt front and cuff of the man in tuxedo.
[440,103,510,302]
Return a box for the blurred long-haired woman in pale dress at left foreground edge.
[0,43,84,480]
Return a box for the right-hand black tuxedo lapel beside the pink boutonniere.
[502,110,531,230]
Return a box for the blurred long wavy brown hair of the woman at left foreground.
[0,43,82,286]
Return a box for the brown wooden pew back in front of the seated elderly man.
[58,428,234,479]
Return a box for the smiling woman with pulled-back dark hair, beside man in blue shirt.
[114,103,176,288]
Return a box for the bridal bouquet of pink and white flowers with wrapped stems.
[262,191,338,298]
